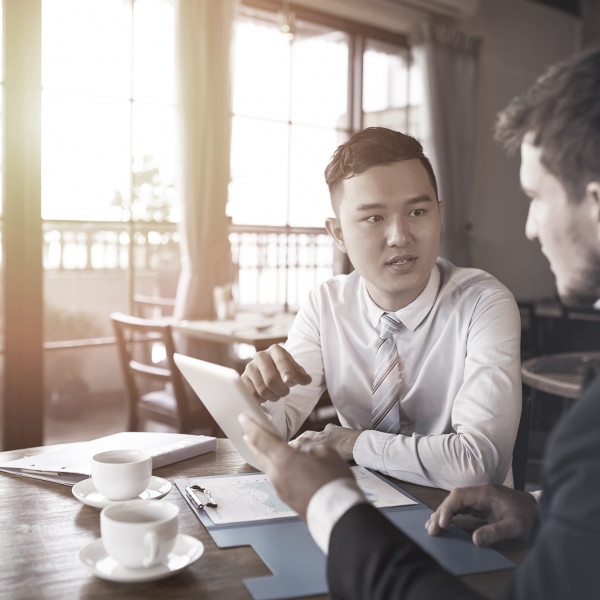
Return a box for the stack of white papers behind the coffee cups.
[0,431,217,485]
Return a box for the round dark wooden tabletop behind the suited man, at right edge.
[521,352,600,399]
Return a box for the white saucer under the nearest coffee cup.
[77,533,204,582]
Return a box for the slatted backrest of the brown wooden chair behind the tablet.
[110,313,190,431]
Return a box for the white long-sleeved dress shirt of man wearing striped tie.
[263,258,521,489]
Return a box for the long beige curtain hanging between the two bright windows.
[175,0,237,319]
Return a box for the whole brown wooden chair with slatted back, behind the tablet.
[110,313,217,435]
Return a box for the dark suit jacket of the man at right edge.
[327,378,600,600]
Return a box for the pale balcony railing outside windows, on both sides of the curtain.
[43,221,333,324]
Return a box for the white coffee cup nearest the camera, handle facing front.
[100,500,179,569]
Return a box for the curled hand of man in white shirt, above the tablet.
[242,344,312,402]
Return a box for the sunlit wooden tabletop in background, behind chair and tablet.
[173,311,295,351]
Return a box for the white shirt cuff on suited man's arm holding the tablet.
[306,477,367,555]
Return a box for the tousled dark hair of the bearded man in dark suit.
[495,47,600,203]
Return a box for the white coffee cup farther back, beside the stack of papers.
[92,449,152,500]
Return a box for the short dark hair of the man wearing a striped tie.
[325,127,438,209]
